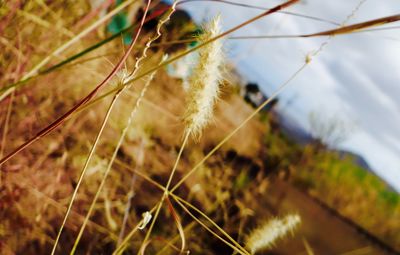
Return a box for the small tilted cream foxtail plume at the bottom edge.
[246,214,301,254]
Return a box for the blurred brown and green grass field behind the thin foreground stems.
[0,0,400,254]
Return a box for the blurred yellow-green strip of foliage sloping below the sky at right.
[265,123,400,247]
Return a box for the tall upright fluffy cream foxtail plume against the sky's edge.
[184,16,223,138]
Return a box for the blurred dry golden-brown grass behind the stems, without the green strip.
[0,1,398,254]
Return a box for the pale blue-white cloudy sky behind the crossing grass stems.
[171,0,400,191]
